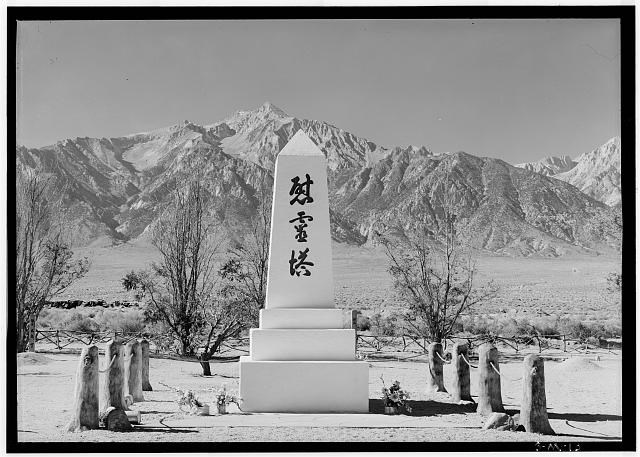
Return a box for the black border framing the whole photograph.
[5,5,636,453]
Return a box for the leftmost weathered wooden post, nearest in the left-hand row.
[66,346,99,432]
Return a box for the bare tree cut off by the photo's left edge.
[15,169,89,352]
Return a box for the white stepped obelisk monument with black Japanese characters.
[240,130,369,413]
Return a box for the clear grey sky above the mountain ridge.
[17,19,620,163]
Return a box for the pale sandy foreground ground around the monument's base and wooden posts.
[17,351,622,442]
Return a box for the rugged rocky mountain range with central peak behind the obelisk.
[16,103,619,255]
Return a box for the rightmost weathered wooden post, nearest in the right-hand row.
[520,354,555,435]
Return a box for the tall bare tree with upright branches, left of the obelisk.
[122,179,222,355]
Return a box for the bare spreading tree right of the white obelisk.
[377,162,497,342]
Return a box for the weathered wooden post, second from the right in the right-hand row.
[476,343,504,416]
